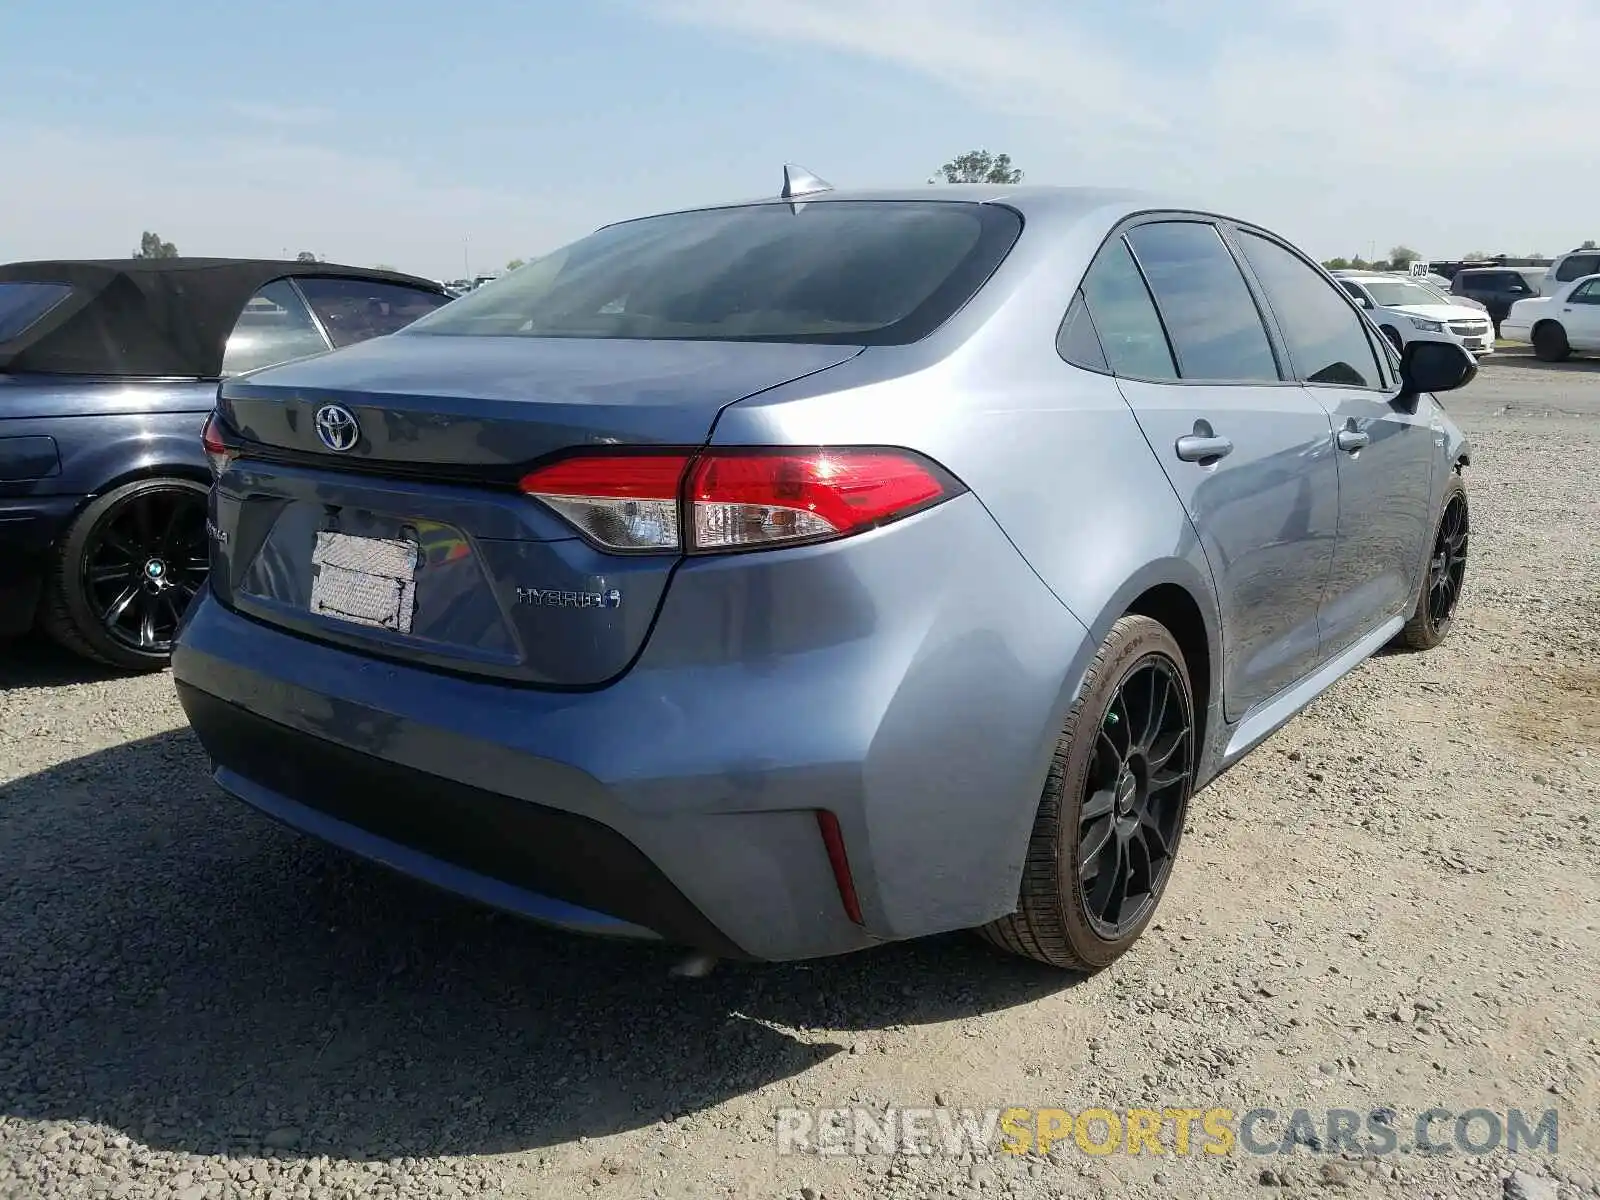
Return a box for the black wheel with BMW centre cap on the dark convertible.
[40,477,208,670]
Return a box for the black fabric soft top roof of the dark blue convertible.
[0,258,445,379]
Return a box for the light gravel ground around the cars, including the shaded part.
[0,357,1600,1200]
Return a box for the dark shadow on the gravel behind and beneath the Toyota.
[0,730,1074,1158]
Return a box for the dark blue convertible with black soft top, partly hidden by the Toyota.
[0,258,451,670]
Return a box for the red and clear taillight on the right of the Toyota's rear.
[522,450,952,552]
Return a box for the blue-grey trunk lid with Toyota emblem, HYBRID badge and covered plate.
[213,334,859,686]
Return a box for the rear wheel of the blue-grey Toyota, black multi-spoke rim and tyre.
[979,616,1198,971]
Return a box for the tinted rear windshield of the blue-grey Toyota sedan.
[403,200,1022,346]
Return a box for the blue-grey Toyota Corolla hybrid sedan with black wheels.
[173,174,1475,970]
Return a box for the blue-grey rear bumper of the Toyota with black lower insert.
[173,496,1093,960]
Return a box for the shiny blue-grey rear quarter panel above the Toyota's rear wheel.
[712,202,1221,764]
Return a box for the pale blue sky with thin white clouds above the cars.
[0,0,1600,278]
